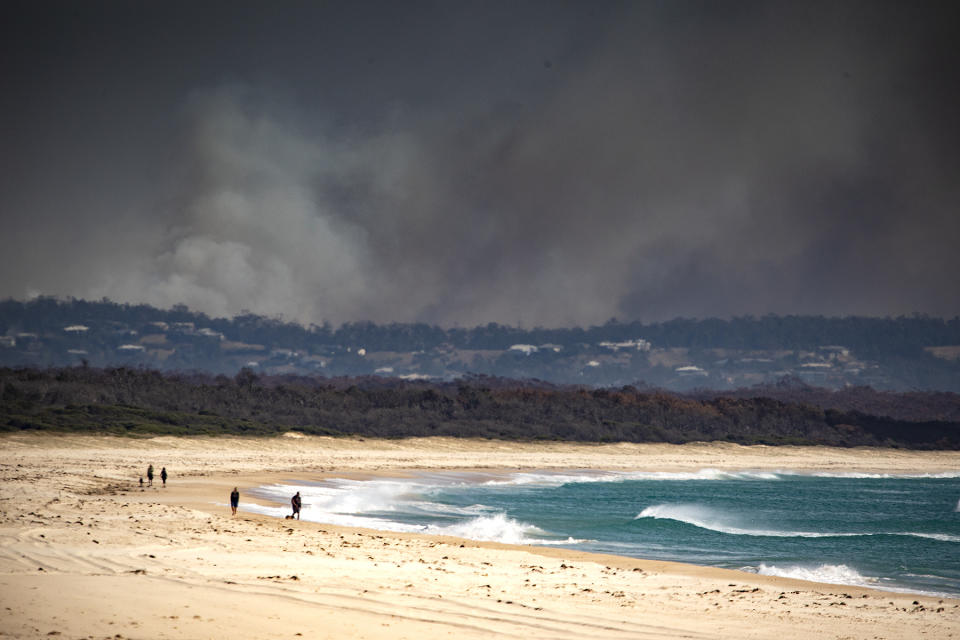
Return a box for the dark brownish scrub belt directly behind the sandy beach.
[0,367,960,449]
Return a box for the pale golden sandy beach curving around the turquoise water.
[0,434,960,640]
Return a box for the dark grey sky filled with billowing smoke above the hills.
[0,0,960,327]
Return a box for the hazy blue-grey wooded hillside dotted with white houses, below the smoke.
[0,298,960,392]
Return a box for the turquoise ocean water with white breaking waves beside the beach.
[246,469,960,597]
